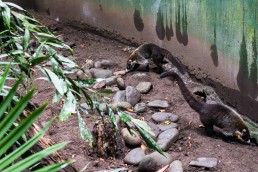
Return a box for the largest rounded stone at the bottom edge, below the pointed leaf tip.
[138,152,172,172]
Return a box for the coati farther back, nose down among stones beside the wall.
[126,43,186,75]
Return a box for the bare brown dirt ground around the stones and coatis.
[30,12,258,172]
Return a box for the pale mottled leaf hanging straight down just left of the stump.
[77,112,93,147]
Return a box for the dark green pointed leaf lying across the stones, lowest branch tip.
[136,125,165,156]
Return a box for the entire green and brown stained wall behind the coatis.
[17,0,258,121]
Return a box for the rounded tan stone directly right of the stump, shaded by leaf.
[121,128,142,147]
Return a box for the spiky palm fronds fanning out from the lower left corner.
[0,65,72,172]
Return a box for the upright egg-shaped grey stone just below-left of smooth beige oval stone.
[125,86,141,106]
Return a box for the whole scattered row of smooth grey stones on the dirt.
[66,60,217,172]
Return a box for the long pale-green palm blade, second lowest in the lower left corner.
[2,142,67,172]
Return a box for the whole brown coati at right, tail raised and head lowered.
[160,71,250,143]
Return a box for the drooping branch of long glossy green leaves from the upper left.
[0,0,162,155]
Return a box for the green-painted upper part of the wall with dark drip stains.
[92,0,258,99]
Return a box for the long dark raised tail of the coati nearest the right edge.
[160,71,205,112]
